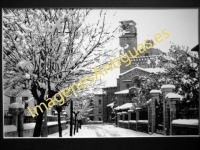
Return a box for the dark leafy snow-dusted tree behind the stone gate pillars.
[136,45,199,108]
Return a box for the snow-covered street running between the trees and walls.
[48,124,163,138]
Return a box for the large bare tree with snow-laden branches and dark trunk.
[3,8,118,137]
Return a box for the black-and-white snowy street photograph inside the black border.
[1,7,199,139]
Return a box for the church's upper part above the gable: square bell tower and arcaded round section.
[119,20,162,74]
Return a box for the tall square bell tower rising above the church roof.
[119,20,137,73]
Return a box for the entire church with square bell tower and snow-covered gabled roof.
[103,20,170,122]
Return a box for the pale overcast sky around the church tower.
[87,8,198,86]
